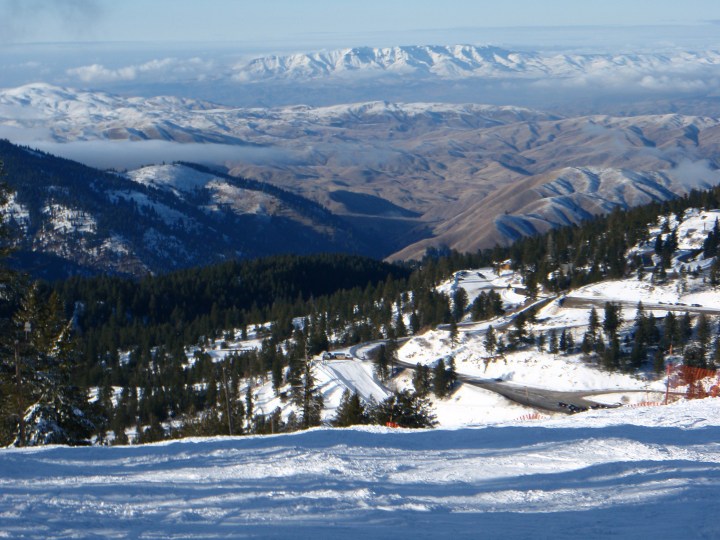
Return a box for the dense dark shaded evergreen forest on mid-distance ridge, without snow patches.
[54,254,410,380]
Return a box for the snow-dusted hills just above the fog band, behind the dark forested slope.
[0,84,557,145]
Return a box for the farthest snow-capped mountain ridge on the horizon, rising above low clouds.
[233,45,720,82]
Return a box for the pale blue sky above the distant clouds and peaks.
[0,0,720,43]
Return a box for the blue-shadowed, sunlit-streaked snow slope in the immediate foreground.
[0,399,720,539]
